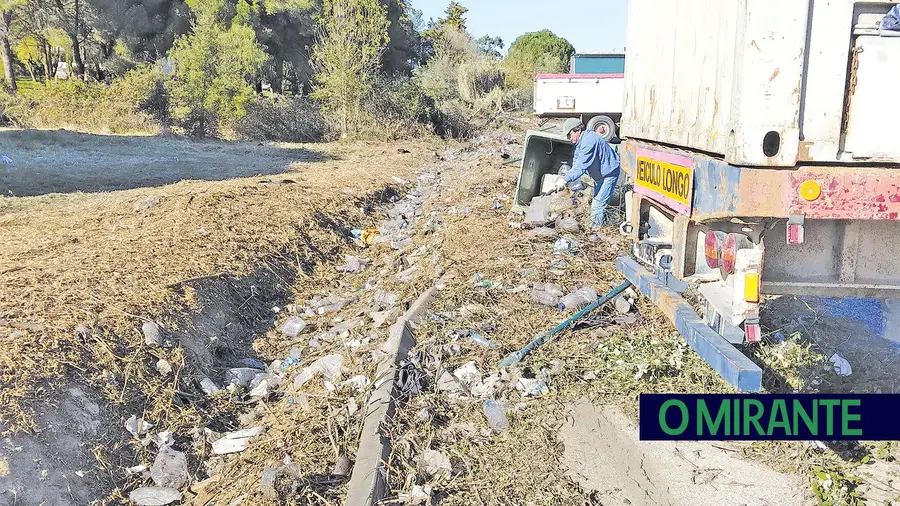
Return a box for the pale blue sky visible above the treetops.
[410,0,628,52]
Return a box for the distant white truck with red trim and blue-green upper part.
[534,53,625,141]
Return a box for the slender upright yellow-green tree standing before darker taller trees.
[313,0,388,136]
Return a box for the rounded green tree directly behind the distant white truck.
[504,30,575,88]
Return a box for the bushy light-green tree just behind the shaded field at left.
[169,0,266,137]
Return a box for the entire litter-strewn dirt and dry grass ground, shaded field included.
[0,122,900,506]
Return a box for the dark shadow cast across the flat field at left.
[0,130,328,197]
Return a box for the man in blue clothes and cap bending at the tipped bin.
[556,118,619,228]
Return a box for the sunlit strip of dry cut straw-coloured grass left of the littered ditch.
[0,133,440,430]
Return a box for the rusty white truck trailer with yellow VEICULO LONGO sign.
[618,0,900,391]
